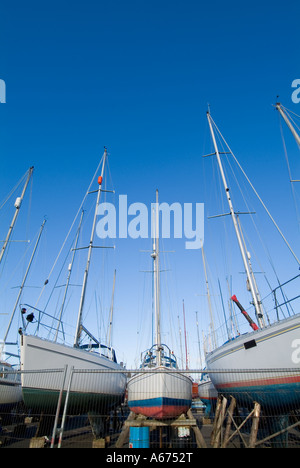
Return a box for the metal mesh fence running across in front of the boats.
[0,367,300,450]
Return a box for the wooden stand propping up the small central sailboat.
[115,409,207,448]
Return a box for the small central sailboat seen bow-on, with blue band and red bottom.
[127,191,192,419]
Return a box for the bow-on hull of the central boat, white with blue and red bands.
[127,367,192,419]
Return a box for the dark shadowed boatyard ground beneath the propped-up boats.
[0,408,300,453]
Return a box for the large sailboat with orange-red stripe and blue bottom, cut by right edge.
[206,112,300,414]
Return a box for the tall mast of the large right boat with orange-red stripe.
[207,112,264,328]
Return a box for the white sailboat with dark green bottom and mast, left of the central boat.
[20,148,126,414]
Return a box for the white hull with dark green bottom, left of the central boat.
[21,335,126,414]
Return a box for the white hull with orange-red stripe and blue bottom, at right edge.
[206,314,300,411]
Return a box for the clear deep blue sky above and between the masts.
[0,0,300,365]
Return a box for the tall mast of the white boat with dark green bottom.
[74,148,107,347]
